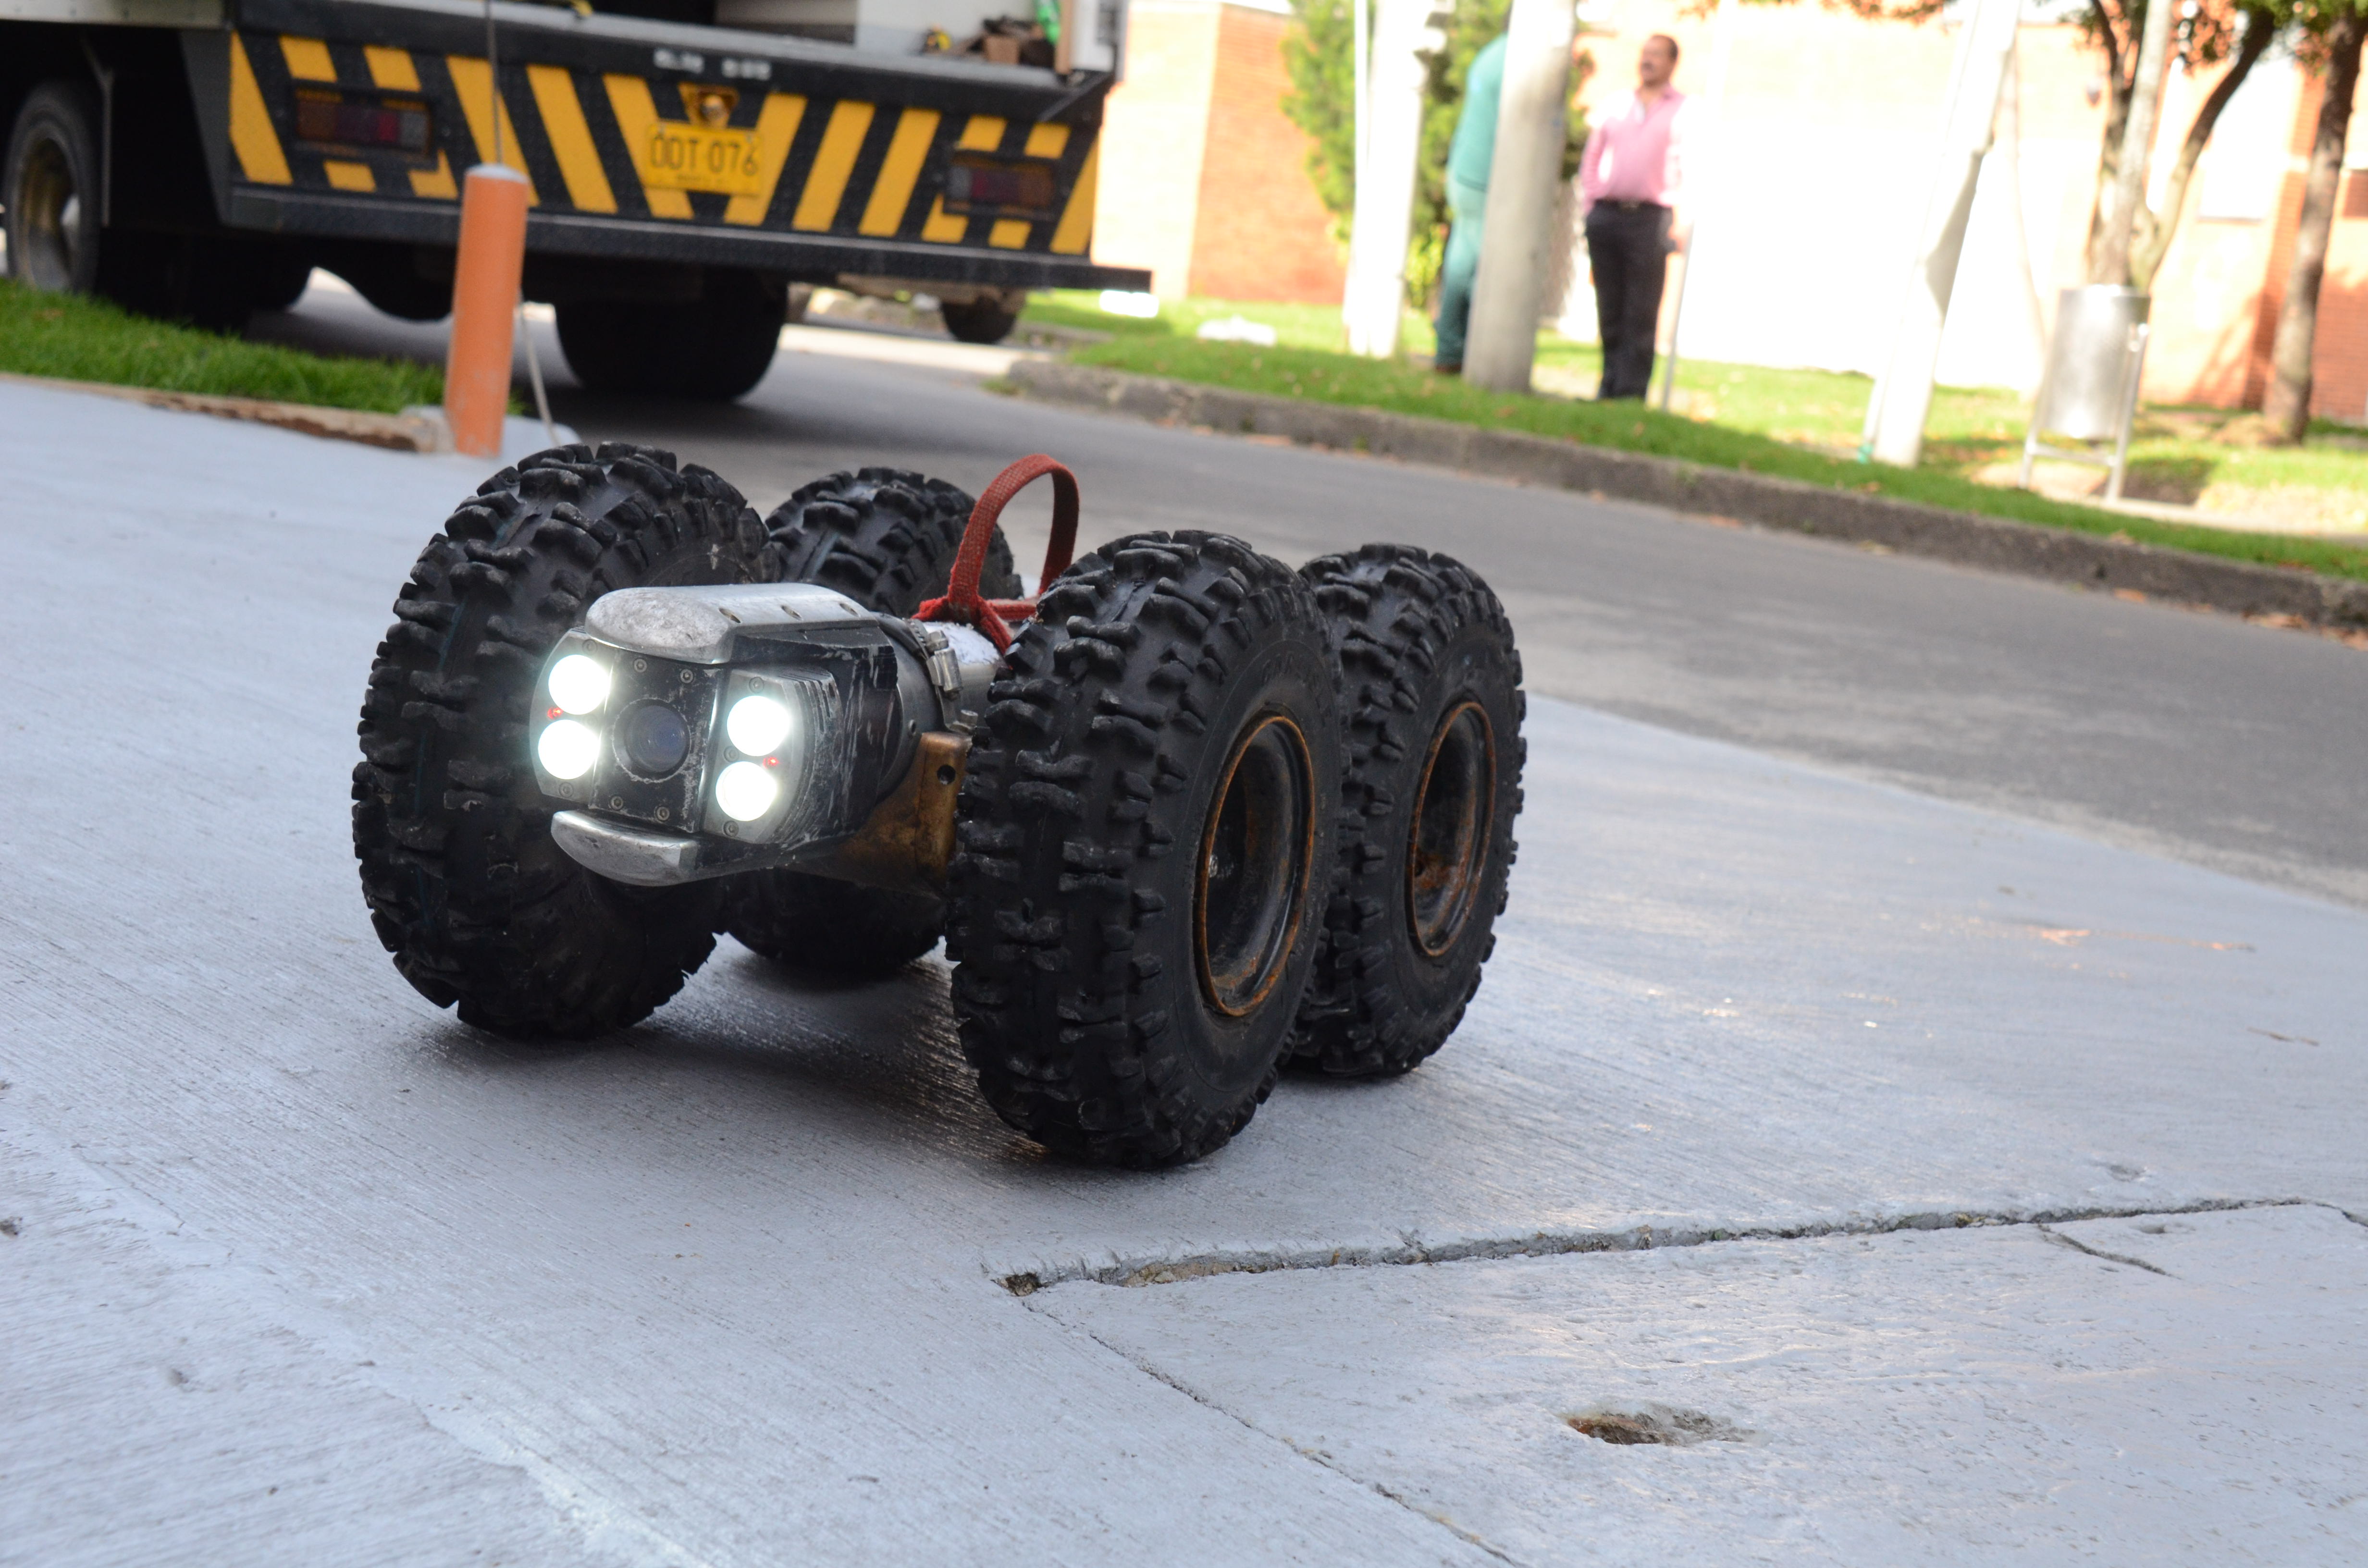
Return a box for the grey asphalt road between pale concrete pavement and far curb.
[245,289,2368,907]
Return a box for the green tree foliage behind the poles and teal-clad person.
[1283,0,1591,303]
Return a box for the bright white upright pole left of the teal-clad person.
[1340,0,1440,360]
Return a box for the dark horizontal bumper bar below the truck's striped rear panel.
[230,185,1151,289]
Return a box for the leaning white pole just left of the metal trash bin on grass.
[1859,0,2017,469]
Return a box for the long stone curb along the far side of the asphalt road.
[1006,360,2368,632]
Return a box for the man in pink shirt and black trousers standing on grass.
[1579,33,1686,400]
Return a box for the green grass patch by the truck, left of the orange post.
[0,280,443,415]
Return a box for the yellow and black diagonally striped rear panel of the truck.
[230,31,1099,258]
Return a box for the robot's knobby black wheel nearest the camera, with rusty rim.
[947,533,1340,1170]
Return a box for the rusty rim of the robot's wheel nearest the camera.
[1194,715,1317,1018]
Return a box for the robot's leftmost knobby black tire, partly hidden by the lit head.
[353,445,765,1040]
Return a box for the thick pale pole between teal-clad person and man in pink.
[1464,0,1572,391]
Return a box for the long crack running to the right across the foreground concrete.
[987,1199,2311,1296]
